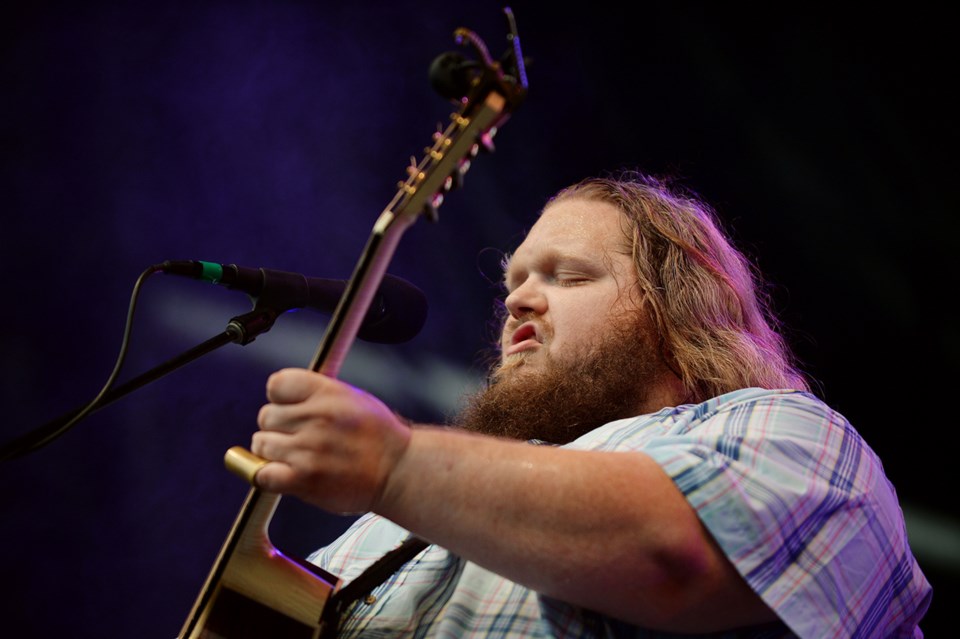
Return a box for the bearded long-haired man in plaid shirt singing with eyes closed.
[251,174,930,639]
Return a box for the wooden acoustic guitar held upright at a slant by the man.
[179,8,527,639]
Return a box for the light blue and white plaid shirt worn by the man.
[310,389,931,639]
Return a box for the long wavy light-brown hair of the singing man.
[548,172,810,401]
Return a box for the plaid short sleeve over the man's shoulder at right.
[568,389,930,639]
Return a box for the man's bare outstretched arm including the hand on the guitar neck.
[252,369,775,632]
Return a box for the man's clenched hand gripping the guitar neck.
[251,368,410,513]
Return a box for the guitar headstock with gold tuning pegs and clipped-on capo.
[377,8,527,231]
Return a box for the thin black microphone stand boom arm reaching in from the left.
[0,303,288,462]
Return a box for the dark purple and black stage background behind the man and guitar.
[0,0,960,638]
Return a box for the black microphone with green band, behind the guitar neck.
[159,260,427,344]
